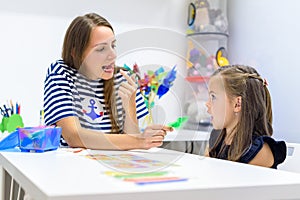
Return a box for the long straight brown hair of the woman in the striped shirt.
[62,13,120,133]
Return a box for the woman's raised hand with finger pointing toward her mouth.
[118,70,138,112]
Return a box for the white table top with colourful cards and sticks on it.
[0,148,300,200]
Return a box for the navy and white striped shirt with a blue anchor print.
[44,60,148,133]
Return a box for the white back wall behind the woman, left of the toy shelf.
[0,0,187,126]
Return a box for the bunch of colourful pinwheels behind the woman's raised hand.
[124,64,177,125]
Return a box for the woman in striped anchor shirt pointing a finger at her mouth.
[44,13,171,150]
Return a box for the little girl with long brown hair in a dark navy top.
[206,65,286,168]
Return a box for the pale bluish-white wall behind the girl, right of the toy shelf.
[228,0,300,142]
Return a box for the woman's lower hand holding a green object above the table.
[139,124,173,149]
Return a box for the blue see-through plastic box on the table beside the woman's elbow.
[18,127,61,152]
